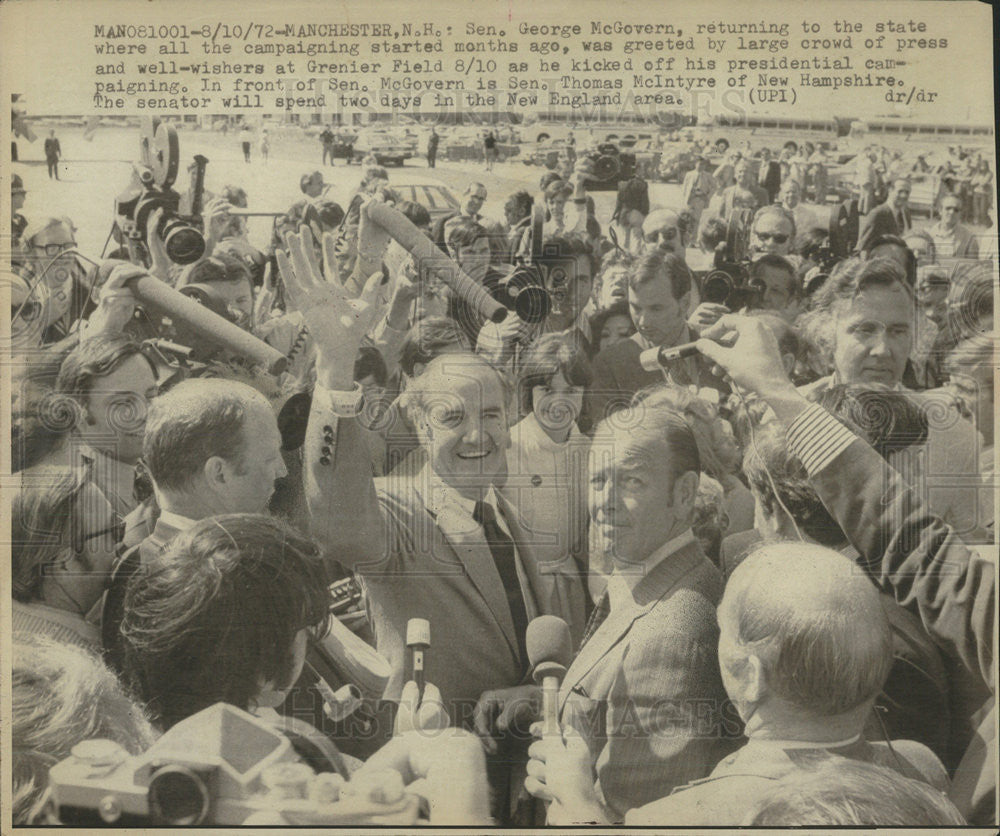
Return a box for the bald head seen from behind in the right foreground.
[719,543,892,716]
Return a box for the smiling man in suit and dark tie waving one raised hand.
[279,224,584,725]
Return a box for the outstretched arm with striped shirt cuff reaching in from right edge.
[699,316,997,824]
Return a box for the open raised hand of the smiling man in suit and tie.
[276,225,382,390]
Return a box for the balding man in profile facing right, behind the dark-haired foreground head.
[101,378,288,669]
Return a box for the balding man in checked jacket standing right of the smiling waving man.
[528,393,725,824]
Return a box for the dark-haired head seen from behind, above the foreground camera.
[121,514,330,729]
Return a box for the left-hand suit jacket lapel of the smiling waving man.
[417,476,519,659]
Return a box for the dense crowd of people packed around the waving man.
[5,125,996,826]
